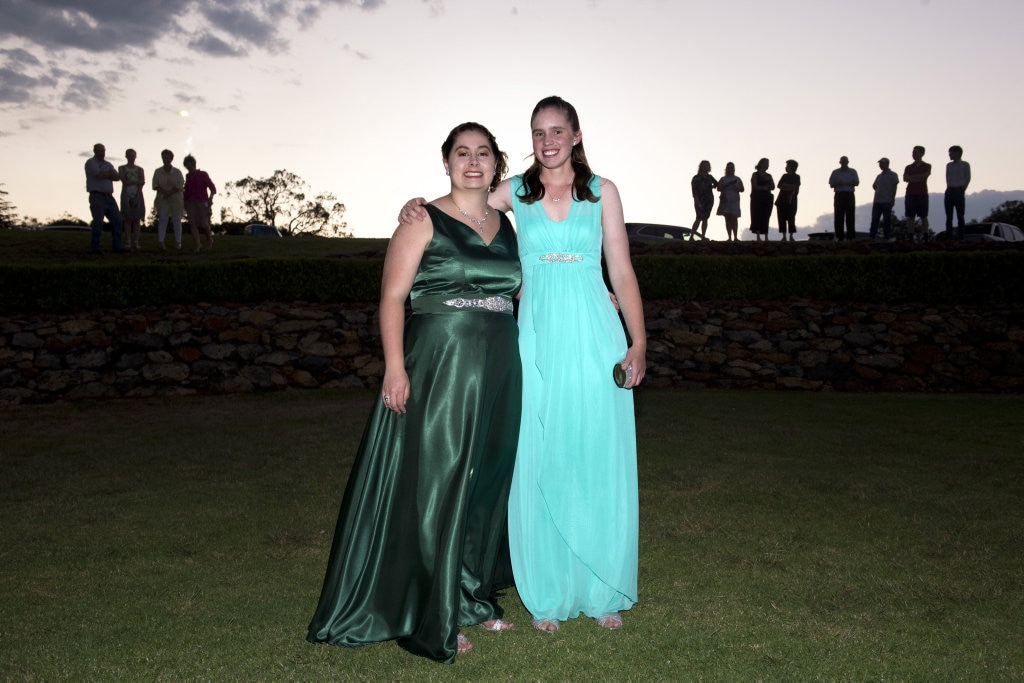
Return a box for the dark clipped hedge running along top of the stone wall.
[0,250,1024,313]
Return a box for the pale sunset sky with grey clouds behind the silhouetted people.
[0,0,1024,239]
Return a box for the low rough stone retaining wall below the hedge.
[0,300,1024,403]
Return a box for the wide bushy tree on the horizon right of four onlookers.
[224,170,352,238]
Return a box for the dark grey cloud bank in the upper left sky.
[0,0,382,109]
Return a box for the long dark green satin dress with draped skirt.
[307,206,522,663]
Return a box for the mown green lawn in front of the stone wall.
[0,387,1024,681]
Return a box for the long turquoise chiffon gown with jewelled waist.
[509,176,639,621]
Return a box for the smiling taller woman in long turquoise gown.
[503,97,647,631]
